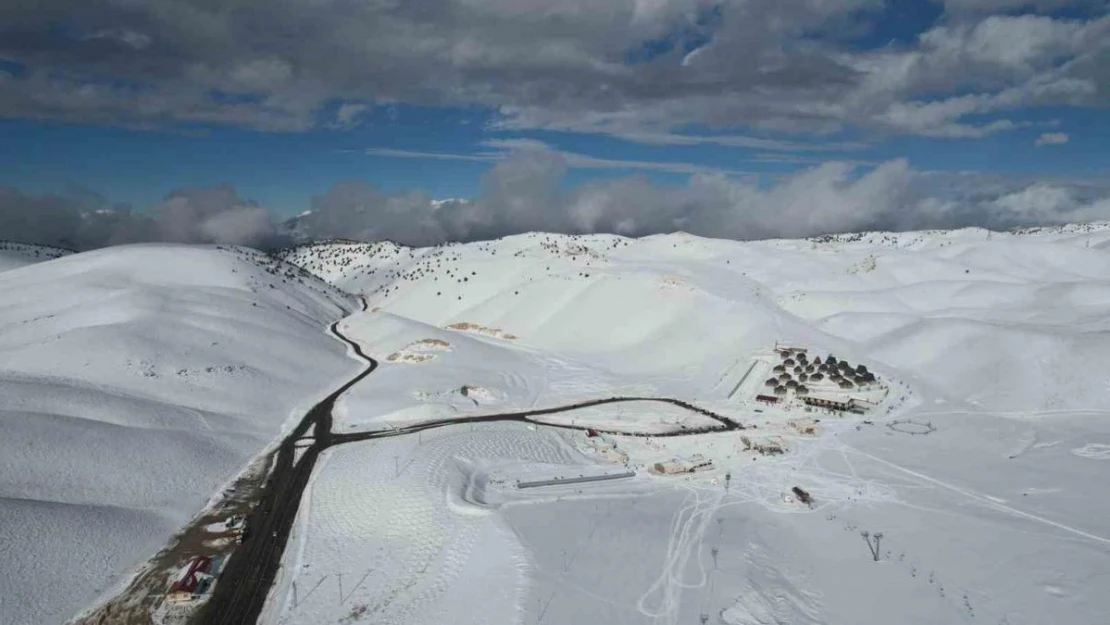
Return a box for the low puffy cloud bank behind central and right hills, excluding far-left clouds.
[302,150,1110,245]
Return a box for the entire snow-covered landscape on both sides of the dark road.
[0,224,1110,625]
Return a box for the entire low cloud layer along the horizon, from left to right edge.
[0,148,1110,250]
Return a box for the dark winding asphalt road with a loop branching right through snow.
[199,298,744,625]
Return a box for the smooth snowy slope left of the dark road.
[0,245,357,625]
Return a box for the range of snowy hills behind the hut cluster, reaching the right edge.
[283,224,1110,410]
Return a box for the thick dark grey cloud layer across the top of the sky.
[0,0,1110,138]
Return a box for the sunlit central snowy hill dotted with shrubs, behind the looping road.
[286,234,843,383]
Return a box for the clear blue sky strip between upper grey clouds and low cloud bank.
[0,105,1110,220]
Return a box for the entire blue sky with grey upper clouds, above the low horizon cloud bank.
[0,0,1110,244]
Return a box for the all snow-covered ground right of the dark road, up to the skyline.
[265,224,1110,625]
